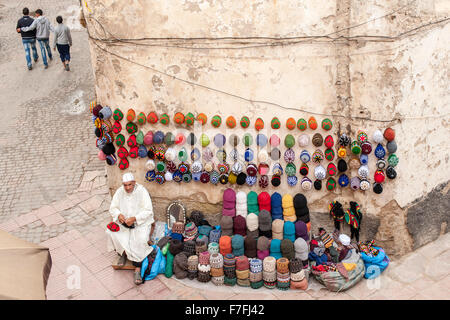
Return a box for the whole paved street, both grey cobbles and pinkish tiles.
[0,0,450,300]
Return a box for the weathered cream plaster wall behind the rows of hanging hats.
[83,0,450,256]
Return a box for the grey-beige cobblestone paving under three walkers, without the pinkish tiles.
[0,0,98,224]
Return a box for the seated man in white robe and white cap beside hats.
[106,173,155,284]
